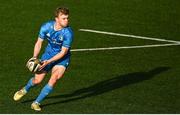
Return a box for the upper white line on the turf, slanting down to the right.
[79,29,180,44]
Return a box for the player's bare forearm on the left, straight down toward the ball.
[33,38,43,58]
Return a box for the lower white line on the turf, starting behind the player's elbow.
[71,44,180,52]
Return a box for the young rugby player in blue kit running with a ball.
[14,8,73,111]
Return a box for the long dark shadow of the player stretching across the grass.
[23,67,170,107]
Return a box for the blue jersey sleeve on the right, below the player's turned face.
[62,31,73,48]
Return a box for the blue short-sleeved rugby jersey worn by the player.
[39,21,73,57]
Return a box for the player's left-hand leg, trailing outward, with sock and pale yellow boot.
[13,72,46,101]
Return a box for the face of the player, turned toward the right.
[56,13,69,27]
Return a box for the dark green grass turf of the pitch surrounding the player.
[0,0,180,114]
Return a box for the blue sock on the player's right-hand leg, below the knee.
[35,84,53,103]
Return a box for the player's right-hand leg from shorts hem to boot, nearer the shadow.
[31,65,66,111]
